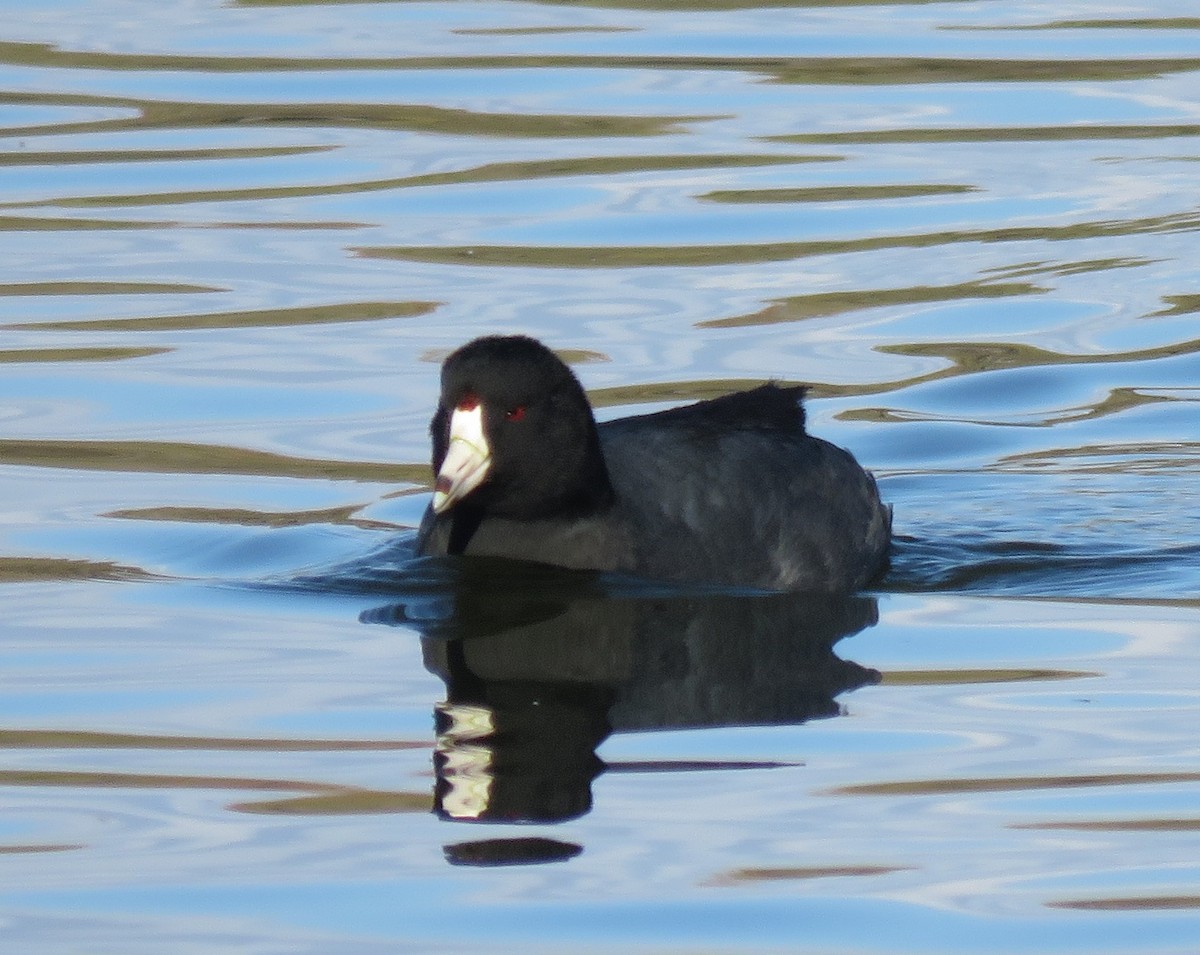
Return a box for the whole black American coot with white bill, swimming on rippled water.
[418,336,892,593]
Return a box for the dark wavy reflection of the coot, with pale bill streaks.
[364,559,880,823]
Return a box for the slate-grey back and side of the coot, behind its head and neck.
[600,385,890,591]
